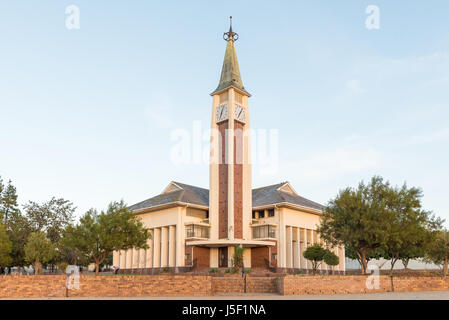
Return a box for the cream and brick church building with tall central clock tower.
[113,18,345,274]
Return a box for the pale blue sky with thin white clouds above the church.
[0,0,449,225]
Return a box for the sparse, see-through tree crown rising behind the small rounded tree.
[24,197,76,243]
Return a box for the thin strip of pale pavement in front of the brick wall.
[5,291,449,300]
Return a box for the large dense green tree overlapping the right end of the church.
[318,176,393,274]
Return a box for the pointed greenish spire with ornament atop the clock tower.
[212,16,250,96]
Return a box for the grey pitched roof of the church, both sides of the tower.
[129,181,324,211]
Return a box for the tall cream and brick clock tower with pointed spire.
[209,17,252,267]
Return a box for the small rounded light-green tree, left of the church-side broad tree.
[25,232,56,274]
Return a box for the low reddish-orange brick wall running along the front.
[0,275,449,298]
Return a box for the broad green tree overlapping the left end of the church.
[63,201,150,274]
